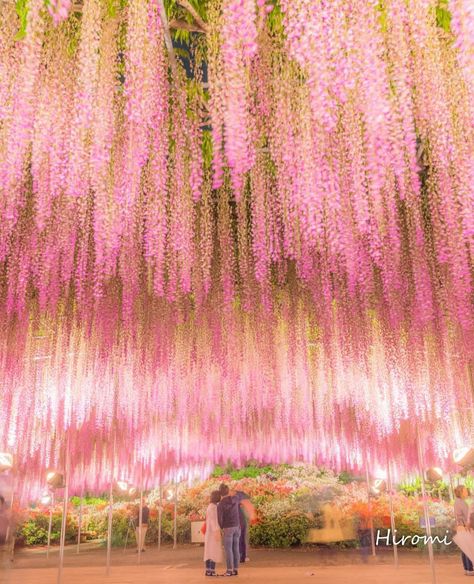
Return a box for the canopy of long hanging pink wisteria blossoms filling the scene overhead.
[0,0,474,500]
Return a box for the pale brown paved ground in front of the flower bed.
[0,546,466,584]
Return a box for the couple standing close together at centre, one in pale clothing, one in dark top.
[204,484,251,576]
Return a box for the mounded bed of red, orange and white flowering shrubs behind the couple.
[14,465,453,550]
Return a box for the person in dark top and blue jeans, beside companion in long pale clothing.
[217,485,240,576]
